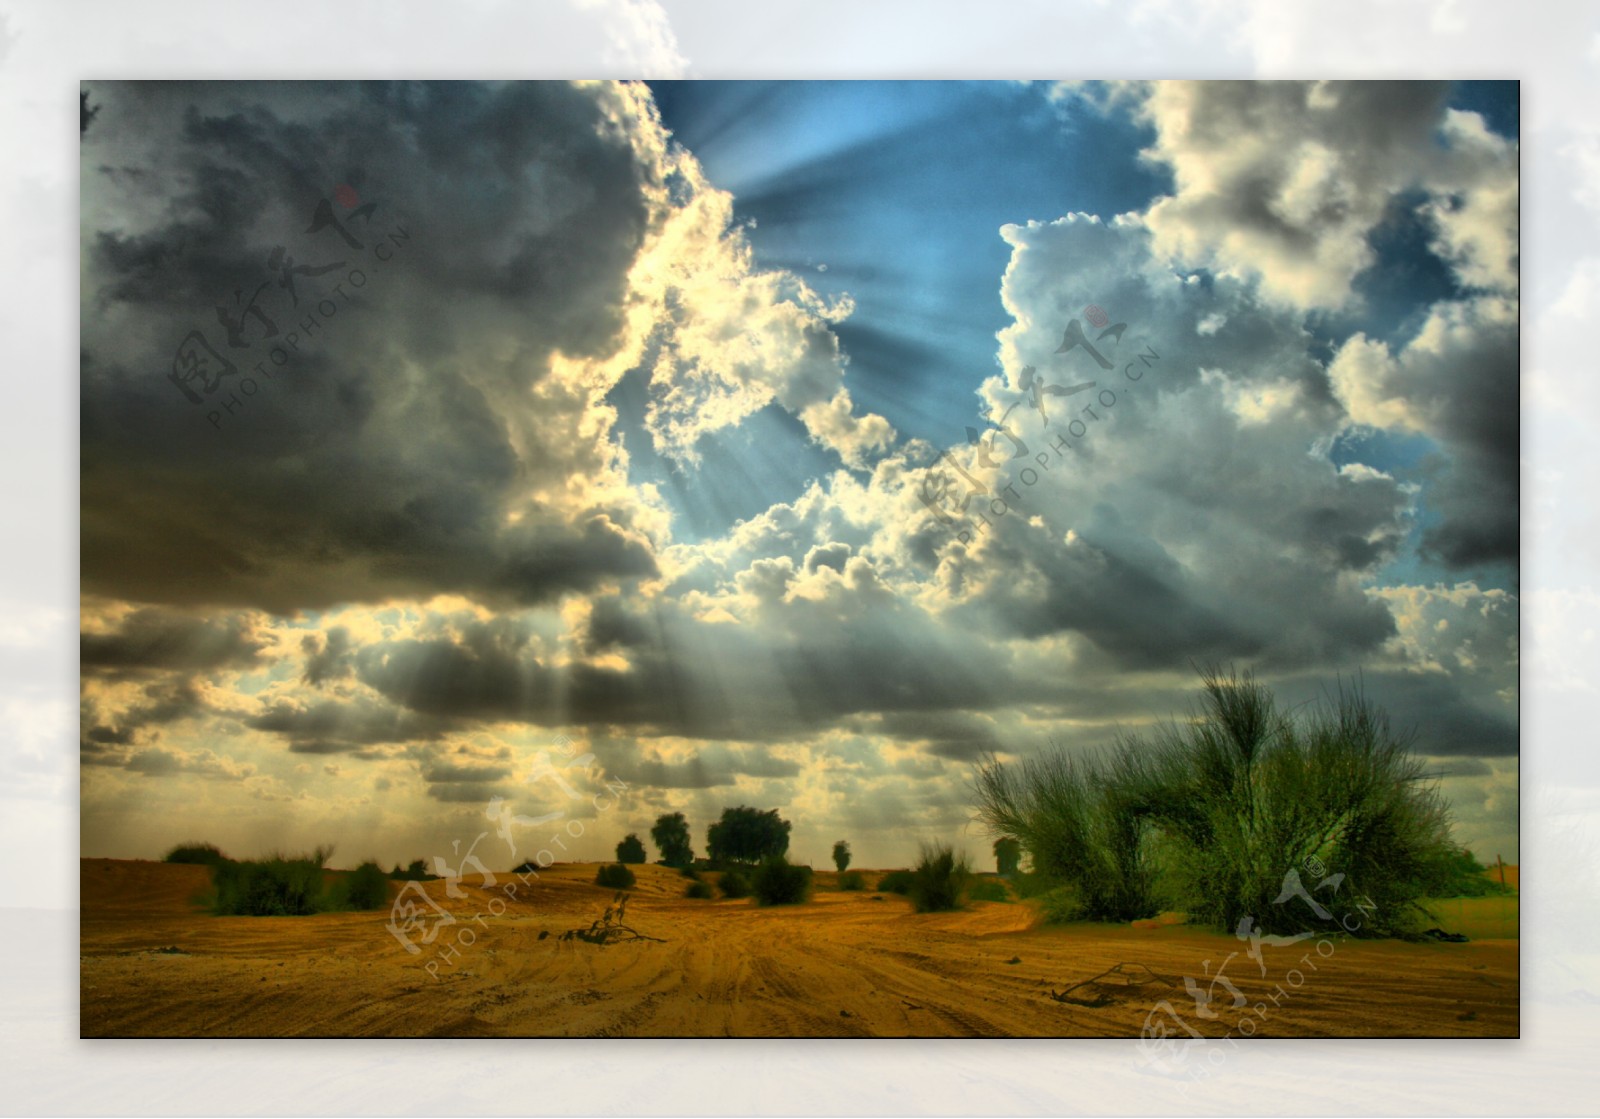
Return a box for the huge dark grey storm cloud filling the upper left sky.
[82,83,654,612]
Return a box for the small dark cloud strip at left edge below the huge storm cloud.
[78,608,269,674]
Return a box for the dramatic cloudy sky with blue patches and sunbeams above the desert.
[80,82,1516,866]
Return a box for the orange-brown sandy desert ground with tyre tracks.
[80,858,1518,1039]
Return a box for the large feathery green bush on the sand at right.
[974,671,1483,935]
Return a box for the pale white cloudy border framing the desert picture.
[0,0,1600,1116]
